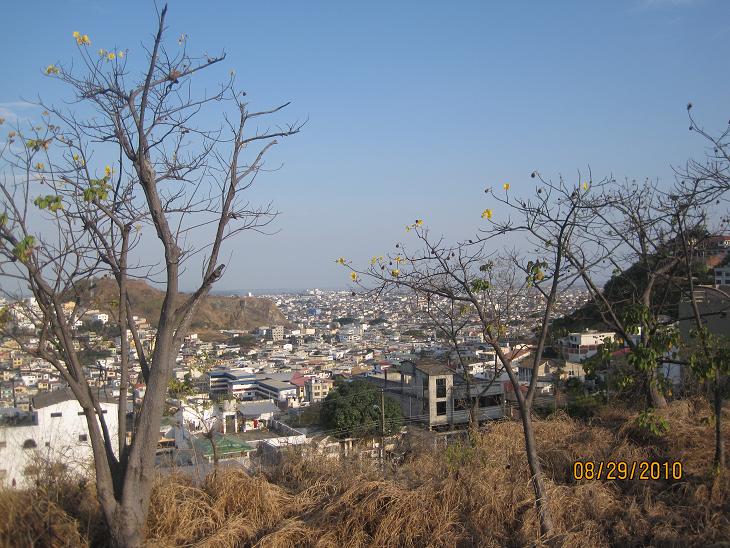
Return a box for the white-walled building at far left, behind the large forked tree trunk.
[0,389,118,487]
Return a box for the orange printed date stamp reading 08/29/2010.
[573,460,682,481]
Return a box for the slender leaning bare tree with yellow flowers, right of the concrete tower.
[338,180,589,538]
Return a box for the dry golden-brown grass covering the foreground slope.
[0,402,730,548]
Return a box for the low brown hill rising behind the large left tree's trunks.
[69,278,290,338]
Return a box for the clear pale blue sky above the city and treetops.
[0,0,730,290]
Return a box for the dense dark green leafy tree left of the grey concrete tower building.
[320,380,403,438]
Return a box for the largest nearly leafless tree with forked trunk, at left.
[0,7,301,546]
